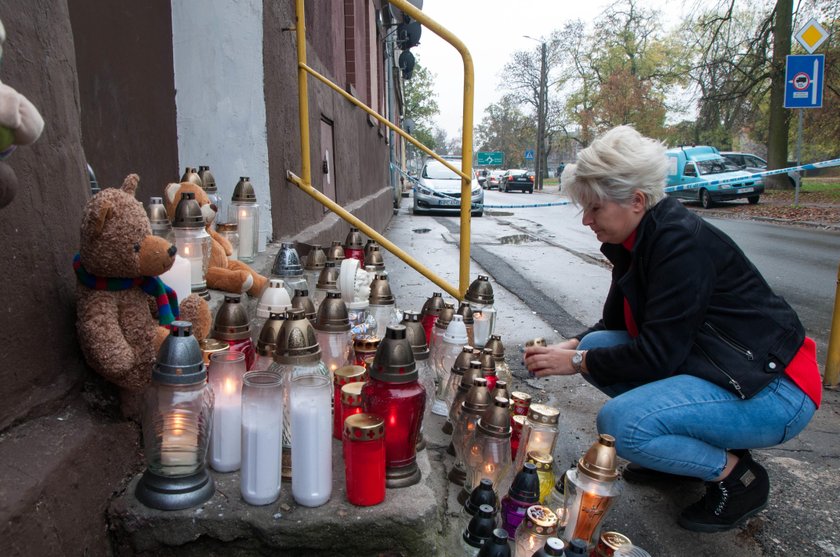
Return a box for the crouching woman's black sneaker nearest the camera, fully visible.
[678,451,770,532]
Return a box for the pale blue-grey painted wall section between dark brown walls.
[172,0,272,251]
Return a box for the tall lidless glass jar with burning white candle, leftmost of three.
[208,351,246,472]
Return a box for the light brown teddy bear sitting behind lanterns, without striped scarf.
[164,182,268,297]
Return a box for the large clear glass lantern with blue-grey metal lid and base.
[135,321,215,510]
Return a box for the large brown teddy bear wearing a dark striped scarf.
[73,174,211,390]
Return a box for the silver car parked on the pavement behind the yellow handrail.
[412,157,484,217]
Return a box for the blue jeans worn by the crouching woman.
[578,331,816,481]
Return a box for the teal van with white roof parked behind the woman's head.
[666,145,764,208]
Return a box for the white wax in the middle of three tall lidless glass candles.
[240,412,283,505]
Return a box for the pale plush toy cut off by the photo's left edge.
[0,21,44,209]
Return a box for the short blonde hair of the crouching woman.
[560,126,668,209]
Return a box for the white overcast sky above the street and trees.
[412,0,696,137]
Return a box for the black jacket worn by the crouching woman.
[577,198,805,398]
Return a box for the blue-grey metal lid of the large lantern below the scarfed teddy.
[152,321,207,385]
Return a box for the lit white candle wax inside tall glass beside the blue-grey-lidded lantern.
[209,377,242,472]
